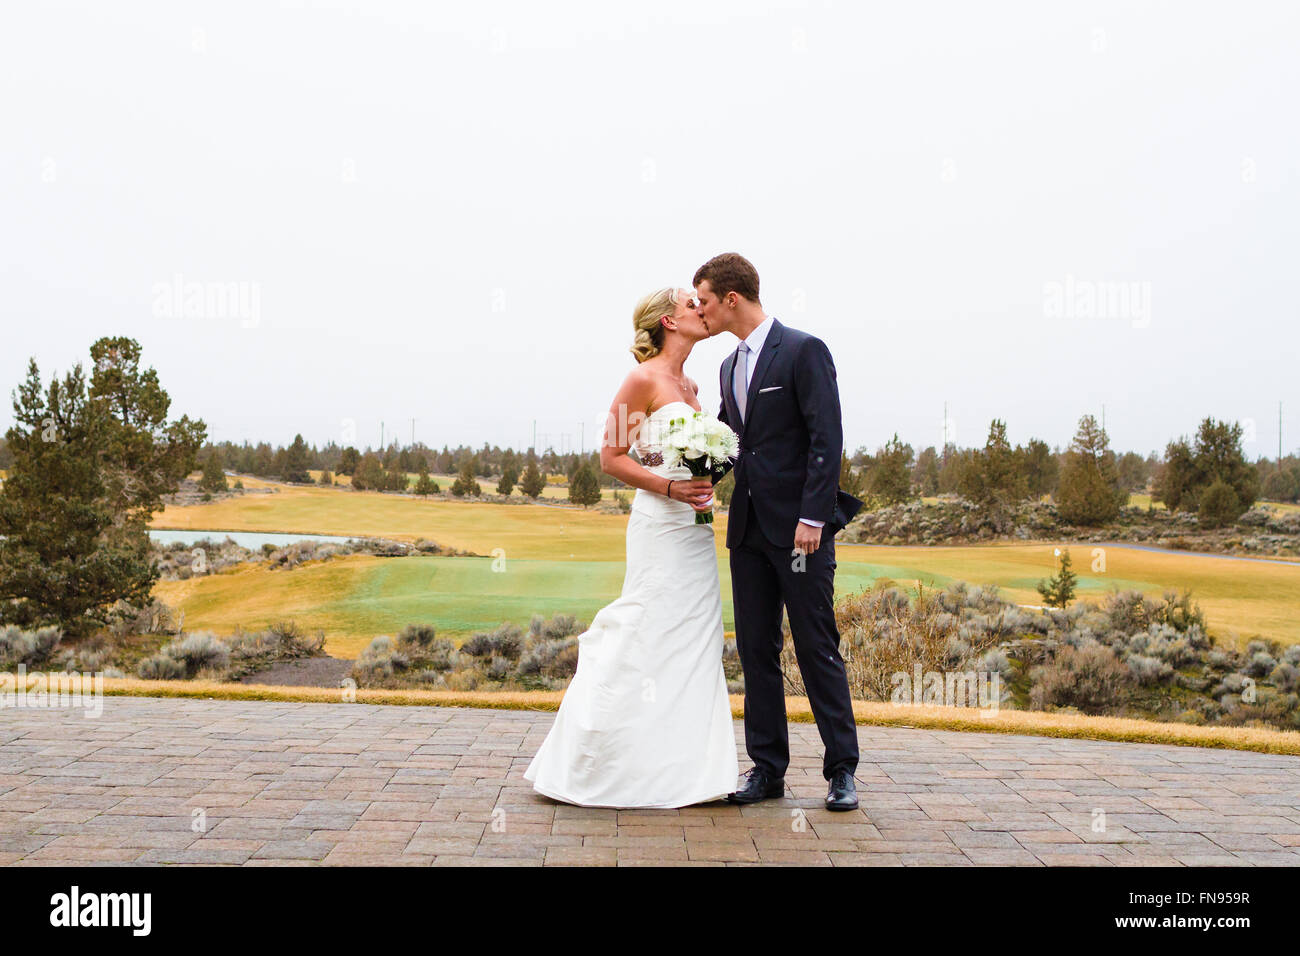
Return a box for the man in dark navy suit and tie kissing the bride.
[694,252,862,810]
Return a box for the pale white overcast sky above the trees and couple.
[0,0,1300,457]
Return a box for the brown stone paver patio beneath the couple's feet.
[0,697,1300,866]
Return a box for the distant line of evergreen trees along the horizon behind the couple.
[185,415,1300,524]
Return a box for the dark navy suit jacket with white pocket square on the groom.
[718,319,862,548]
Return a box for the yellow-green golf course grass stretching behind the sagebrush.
[155,480,1300,656]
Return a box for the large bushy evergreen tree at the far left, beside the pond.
[0,338,207,635]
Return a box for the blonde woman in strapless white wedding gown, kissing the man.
[524,289,738,808]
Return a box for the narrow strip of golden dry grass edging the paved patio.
[89,678,1300,754]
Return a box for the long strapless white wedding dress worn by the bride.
[524,402,738,808]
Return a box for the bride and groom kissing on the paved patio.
[524,252,862,810]
